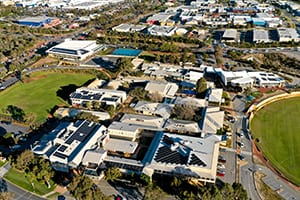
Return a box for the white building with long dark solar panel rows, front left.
[32,121,107,172]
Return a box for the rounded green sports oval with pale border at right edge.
[251,97,300,186]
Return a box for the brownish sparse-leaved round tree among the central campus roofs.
[172,104,195,120]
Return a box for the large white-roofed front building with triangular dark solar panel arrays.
[143,133,219,183]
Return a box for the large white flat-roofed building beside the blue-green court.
[46,39,104,61]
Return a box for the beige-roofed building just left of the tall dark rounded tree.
[145,81,179,98]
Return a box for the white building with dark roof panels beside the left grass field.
[70,87,127,107]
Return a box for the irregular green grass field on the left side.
[0,72,94,122]
